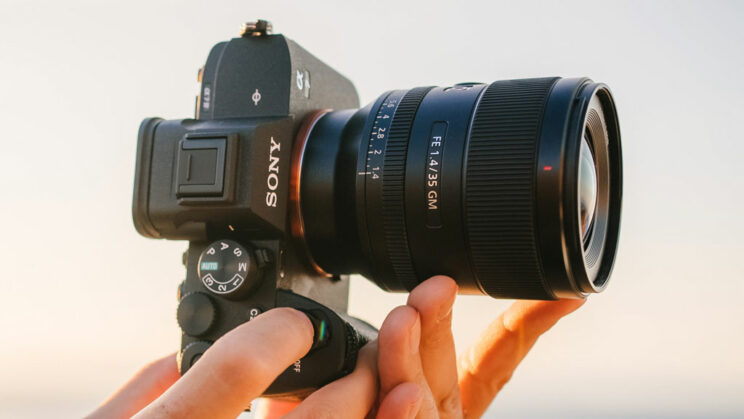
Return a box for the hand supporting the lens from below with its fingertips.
[377,276,584,419]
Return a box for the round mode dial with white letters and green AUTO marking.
[197,240,260,299]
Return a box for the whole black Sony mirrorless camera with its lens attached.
[133,20,622,397]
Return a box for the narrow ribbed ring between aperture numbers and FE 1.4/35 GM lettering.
[382,87,432,290]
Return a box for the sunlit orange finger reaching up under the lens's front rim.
[458,300,584,417]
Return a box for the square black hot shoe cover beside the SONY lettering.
[176,138,227,198]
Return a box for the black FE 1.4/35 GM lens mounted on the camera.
[291,78,622,299]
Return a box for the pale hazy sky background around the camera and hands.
[0,0,744,417]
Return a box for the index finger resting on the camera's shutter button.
[137,308,313,418]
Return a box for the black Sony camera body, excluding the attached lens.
[133,31,375,397]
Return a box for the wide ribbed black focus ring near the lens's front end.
[464,78,558,299]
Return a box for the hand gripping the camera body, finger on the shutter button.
[89,308,378,418]
